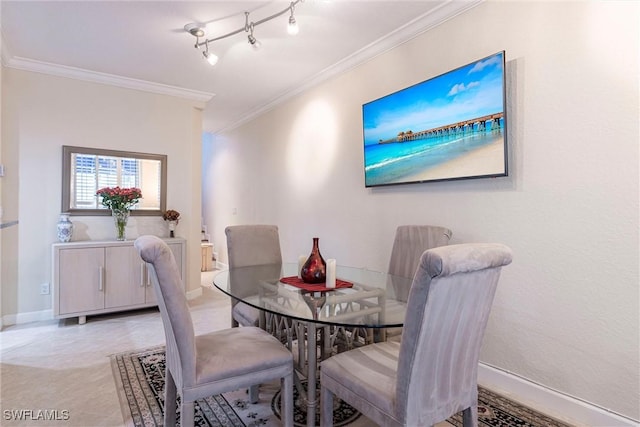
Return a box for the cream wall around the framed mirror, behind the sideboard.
[2,68,202,323]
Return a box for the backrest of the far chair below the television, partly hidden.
[389,225,452,279]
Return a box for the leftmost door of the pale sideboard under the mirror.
[58,248,105,314]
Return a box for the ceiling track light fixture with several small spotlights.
[184,0,304,65]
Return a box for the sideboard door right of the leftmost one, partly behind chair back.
[105,246,146,308]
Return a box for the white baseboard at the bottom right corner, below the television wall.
[478,363,640,427]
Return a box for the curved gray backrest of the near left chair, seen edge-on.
[134,236,196,389]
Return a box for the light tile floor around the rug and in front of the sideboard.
[0,272,450,427]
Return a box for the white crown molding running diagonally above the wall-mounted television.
[211,0,485,134]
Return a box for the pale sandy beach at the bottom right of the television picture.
[403,138,504,181]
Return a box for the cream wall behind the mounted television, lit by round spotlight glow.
[203,1,640,420]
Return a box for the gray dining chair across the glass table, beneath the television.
[386,225,452,339]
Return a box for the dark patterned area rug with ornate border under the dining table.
[111,346,570,427]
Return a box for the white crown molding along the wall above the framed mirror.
[2,55,215,103]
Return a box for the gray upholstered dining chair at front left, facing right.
[134,236,293,427]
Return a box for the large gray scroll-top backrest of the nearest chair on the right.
[396,243,512,425]
